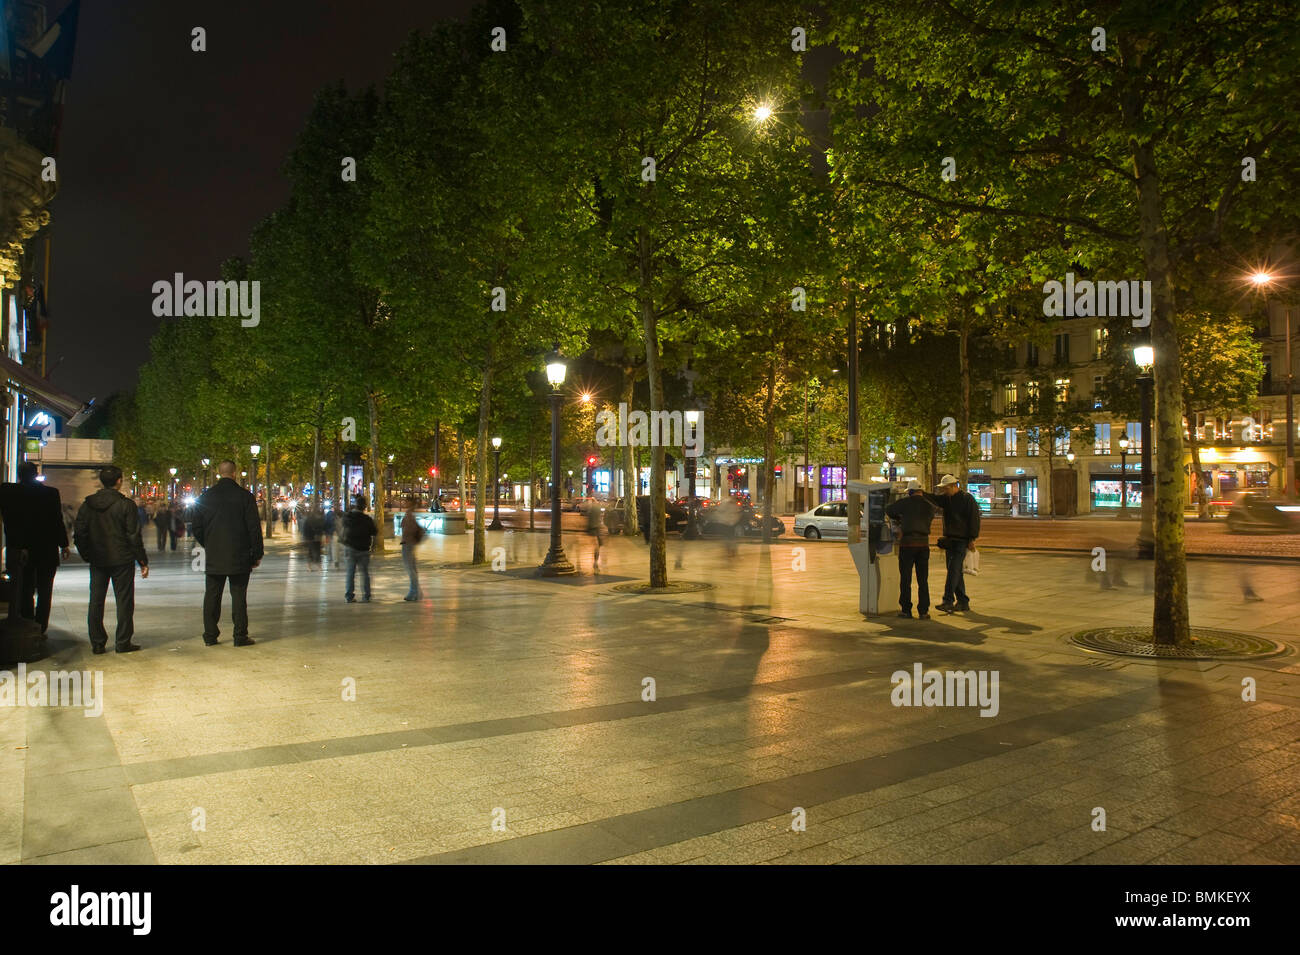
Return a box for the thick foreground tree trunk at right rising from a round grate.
[1125,138,1191,646]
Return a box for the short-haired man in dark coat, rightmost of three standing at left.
[194,461,263,647]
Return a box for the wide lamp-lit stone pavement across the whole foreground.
[0,531,1300,864]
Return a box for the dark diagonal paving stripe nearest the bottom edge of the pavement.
[406,685,1199,865]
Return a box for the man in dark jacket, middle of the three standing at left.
[73,465,150,654]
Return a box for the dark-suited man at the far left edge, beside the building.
[0,461,72,635]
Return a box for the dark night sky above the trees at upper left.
[48,0,473,401]
